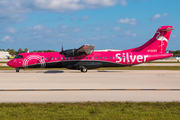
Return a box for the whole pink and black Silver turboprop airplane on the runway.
[7,26,174,73]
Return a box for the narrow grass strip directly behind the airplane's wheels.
[0,66,180,70]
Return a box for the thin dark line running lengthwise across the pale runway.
[0,89,180,91]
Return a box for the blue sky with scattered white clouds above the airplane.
[0,0,180,51]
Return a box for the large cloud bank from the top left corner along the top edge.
[0,0,127,24]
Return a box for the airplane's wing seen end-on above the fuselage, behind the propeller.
[77,45,95,55]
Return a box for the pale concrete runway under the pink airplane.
[0,70,180,102]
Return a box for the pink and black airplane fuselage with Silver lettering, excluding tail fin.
[7,50,172,69]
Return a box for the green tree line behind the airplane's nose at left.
[0,48,57,56]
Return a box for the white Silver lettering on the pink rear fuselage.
[116,53,148,64]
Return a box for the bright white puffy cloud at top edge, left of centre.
[33,0,121,12]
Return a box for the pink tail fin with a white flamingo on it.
[133,26,174,53]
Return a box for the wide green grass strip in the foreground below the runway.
[0,102,180,120]
